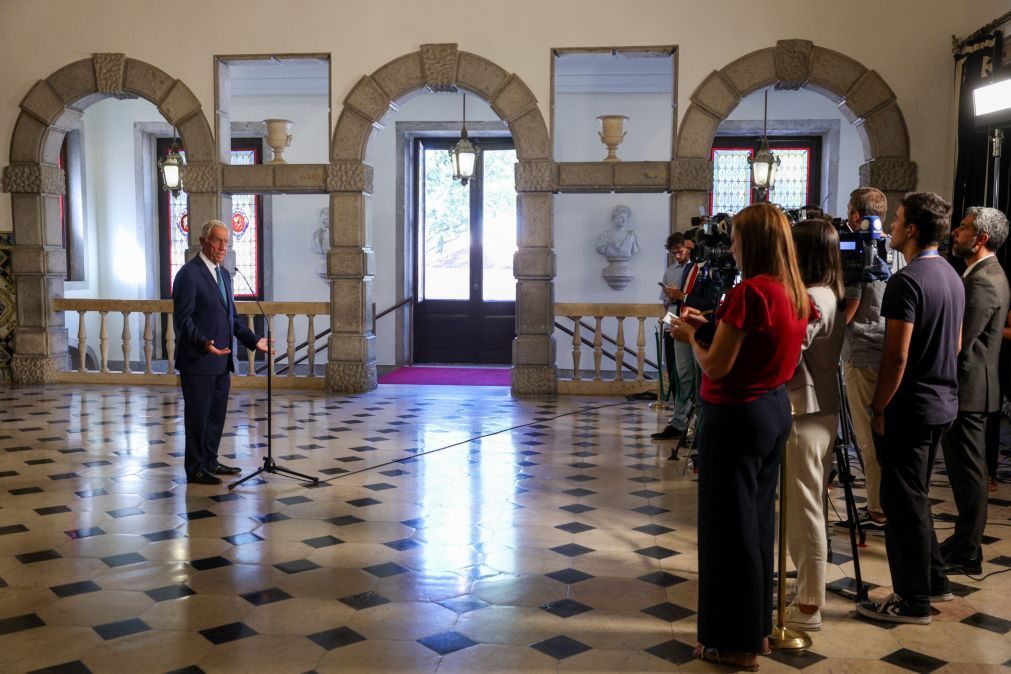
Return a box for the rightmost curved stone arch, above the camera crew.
[673,39,916,229]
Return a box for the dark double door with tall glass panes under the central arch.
[412,136,517,365]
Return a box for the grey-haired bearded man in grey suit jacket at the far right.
[941,208,1011,573]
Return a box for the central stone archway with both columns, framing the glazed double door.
[327,44,557,395]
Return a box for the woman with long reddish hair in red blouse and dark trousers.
[670,203,811,671]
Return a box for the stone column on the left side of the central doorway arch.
[327,160,378,393]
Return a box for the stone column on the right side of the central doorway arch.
[513,160,558,395]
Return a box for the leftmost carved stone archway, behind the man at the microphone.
[3,54,219,384]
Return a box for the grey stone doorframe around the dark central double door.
[392,121,516,366]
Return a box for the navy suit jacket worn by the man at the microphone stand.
[172,255,259,375]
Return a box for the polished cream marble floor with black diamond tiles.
[0,386,1011,673]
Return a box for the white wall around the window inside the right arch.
[718,88,863,217]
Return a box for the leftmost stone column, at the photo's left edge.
[3,162,70,384]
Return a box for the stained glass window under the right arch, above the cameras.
[710,138,817,214]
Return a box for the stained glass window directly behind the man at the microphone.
[165,144,263,299]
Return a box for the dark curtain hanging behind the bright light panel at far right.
[951,32,1011,271]
